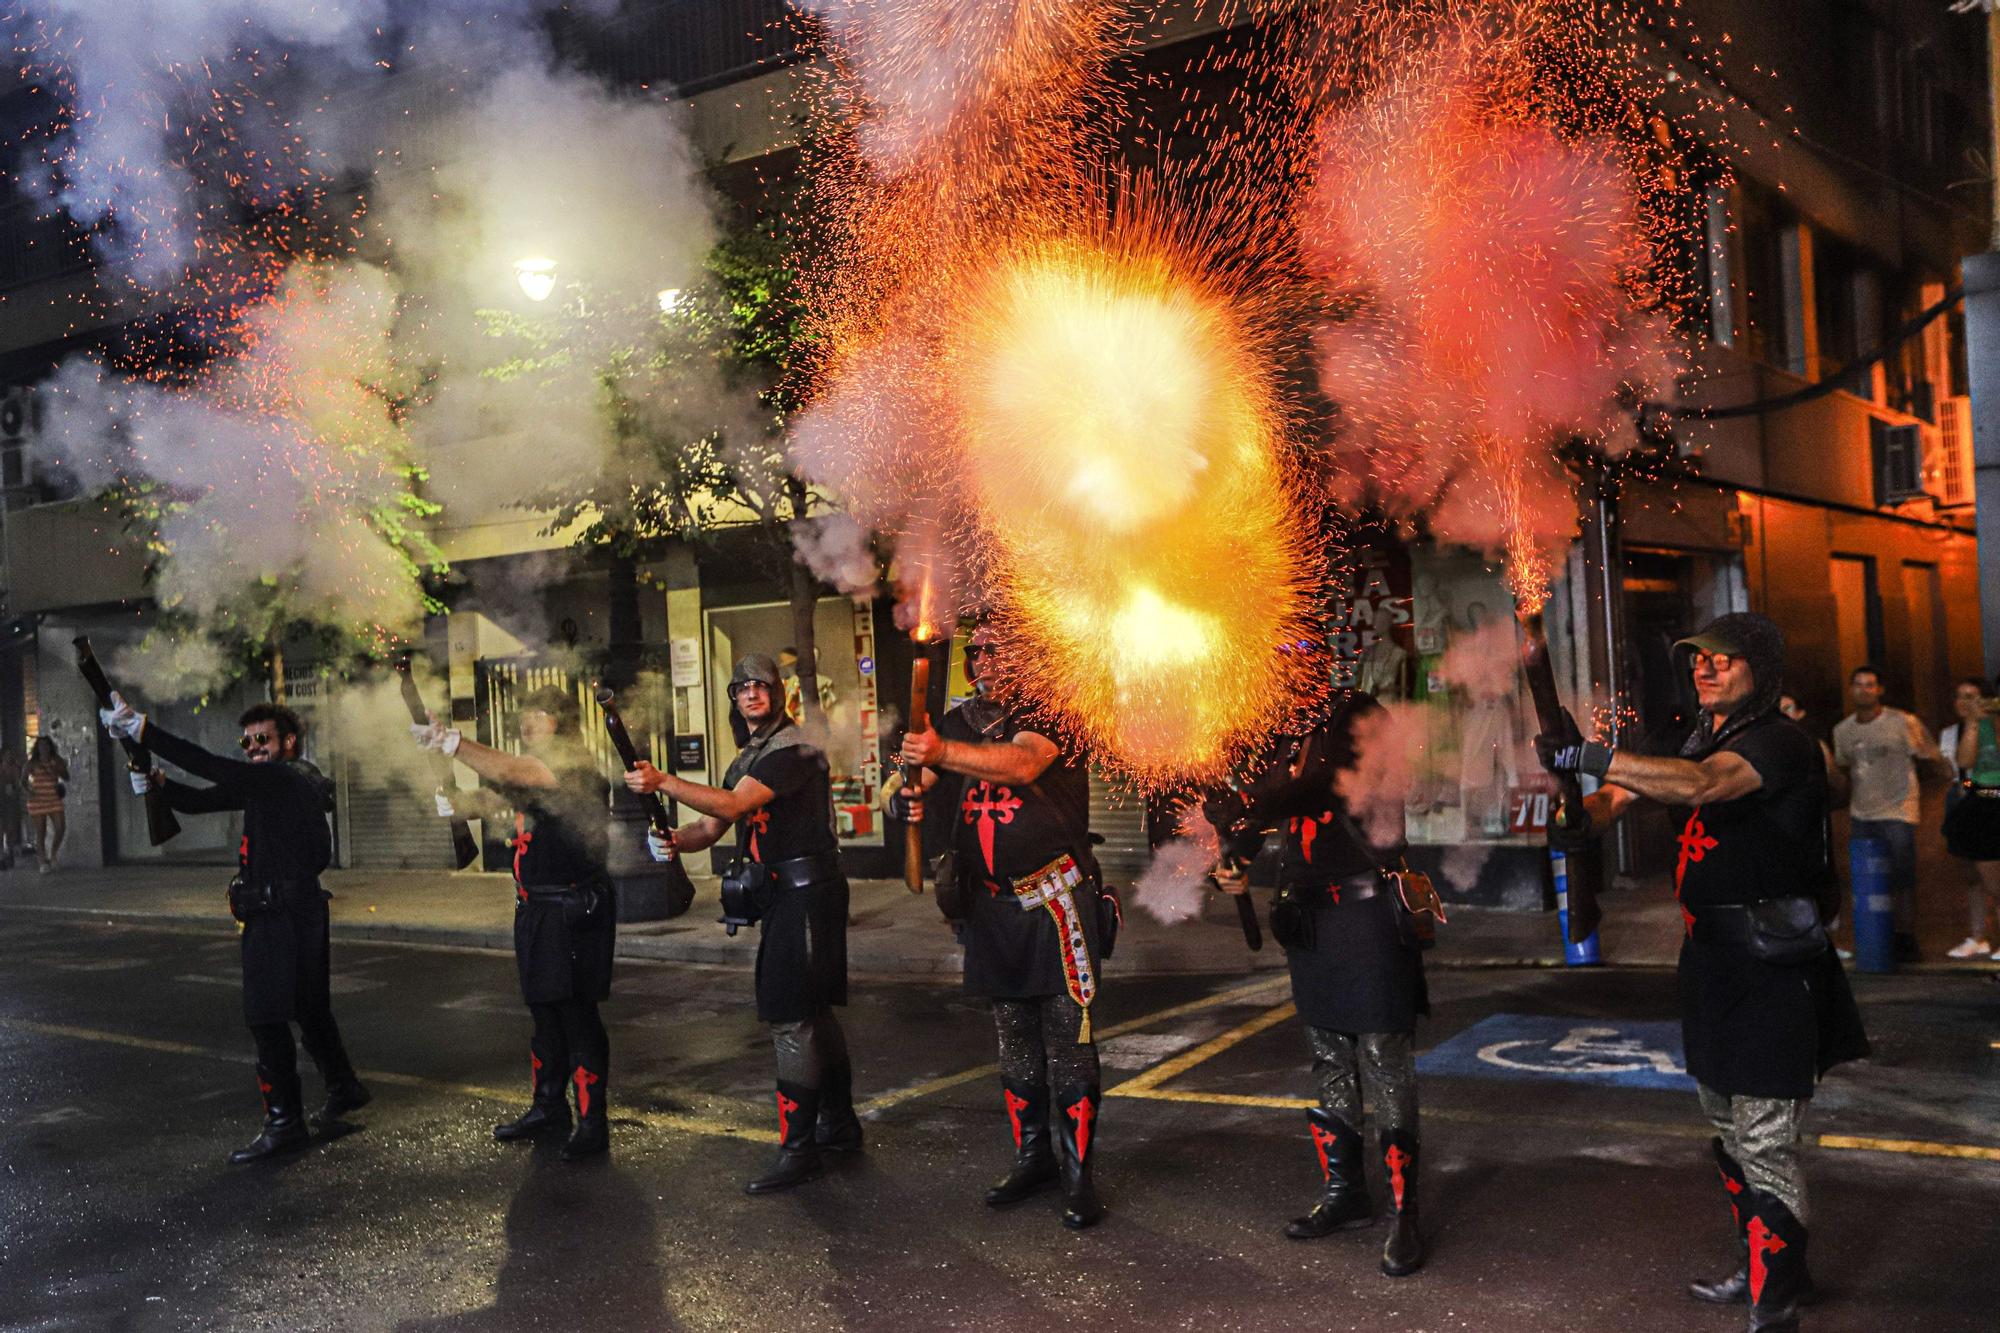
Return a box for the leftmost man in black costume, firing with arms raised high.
[98,695,370,1165]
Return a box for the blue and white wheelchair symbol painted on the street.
[1416,1013,1694,1091]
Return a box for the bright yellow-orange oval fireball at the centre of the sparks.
[950,224,1308,783]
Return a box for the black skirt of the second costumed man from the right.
[1284,893,1430,1033]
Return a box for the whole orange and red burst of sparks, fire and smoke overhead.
[798,0,1744,785]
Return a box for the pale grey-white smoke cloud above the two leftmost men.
[20,0,736,691]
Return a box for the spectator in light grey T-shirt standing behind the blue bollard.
[1834,667,1944,963]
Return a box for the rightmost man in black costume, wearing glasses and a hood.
[1536,612,1868,1333]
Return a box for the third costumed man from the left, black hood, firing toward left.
[626,652,862,1195]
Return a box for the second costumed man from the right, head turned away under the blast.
[1216,691,1430,1277]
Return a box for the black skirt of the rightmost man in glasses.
[1678,939,1868,1101]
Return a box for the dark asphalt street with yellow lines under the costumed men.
[0,896,2000,1333]
